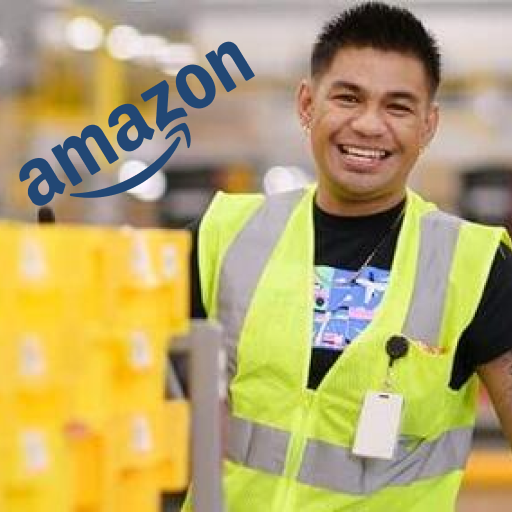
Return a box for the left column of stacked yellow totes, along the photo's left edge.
[0,224,100,512]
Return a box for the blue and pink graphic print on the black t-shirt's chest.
[313,266,389,351]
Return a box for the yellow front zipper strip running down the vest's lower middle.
[273,389,316,512]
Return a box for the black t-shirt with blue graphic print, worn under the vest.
[190,198,512,389]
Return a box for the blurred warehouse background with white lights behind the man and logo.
[0,0,512,512]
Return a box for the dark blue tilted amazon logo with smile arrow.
[20,42,254,206]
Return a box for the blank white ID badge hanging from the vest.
[352,391,403,460]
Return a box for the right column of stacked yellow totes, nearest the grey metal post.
[99,229,189,512]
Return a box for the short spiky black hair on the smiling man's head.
[311,2,441,97]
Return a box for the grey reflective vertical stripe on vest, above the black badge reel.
[402,211,462,346]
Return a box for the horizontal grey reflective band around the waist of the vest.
[227,416,473,494]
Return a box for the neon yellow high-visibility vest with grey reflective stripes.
[185,187,511,512]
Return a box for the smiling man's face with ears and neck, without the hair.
[298,47,438,210]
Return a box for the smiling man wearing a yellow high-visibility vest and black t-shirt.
[186,2,512,512]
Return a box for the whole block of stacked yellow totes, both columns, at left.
[0,223,189,512]
